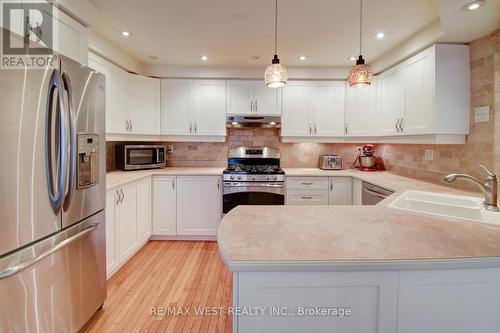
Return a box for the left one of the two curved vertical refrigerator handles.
[45,69,67,215]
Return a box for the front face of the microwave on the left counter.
[125,145,165,170]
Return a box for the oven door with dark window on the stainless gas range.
[222,182,285,214]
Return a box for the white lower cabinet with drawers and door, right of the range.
[286,177,352,205]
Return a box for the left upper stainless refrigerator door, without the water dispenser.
[0,42,62,257]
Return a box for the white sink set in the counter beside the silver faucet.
[388,190,500,225]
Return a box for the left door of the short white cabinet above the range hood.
[227,80,255,115]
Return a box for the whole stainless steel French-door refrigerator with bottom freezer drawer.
[0,29,106,332]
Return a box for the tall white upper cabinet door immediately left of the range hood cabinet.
[194,80,226,135]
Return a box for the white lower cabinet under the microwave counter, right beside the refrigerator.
[106,178,151,278]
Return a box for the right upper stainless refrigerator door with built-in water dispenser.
[61,56,106,228]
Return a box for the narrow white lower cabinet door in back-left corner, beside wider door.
[153,176,177,236]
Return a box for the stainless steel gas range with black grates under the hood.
[223,147,285,214]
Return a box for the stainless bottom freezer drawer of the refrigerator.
[0,212,106,332]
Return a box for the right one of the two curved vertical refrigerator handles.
[62,73,76,211]
